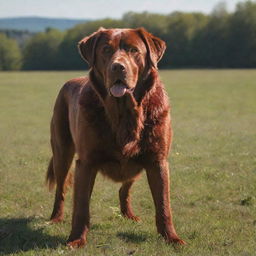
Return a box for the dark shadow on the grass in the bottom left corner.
[0,217,65,255]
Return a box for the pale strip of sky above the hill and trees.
[0,0,250,19]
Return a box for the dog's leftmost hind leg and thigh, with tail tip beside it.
[47,91,75,222]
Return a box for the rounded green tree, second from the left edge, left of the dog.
[23,28,64,70]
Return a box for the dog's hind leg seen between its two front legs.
[119,180,140,221]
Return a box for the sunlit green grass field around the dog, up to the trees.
[0,70,256,256]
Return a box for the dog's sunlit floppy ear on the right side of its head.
[137,28,166,68]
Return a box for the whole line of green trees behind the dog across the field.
[0,1,256,70]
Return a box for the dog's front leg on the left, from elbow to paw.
[67,160,96,247]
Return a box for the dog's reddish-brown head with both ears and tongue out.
[79,28,166,97]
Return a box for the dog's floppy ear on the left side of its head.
[78,27,105,67]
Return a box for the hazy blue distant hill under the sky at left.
[0,17,90,32]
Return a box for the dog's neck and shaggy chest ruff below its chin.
[90,70,158,157]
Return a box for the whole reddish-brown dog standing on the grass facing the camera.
[47,28,184,247]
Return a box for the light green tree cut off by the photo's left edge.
[0,34,21,70]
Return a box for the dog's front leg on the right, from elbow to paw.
[146,161,185,244]
